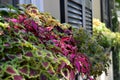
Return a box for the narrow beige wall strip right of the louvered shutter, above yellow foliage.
[93,0,101,20]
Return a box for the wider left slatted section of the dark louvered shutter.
[67,0,83,28]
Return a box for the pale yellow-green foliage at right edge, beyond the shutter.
[93,19,120,48]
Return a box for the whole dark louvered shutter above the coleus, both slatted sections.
[60,0,92,33]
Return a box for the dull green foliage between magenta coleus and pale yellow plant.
[73,28,110,77]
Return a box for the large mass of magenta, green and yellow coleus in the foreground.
[0,4,91,80]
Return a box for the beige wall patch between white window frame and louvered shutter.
[43,0,60,20]
